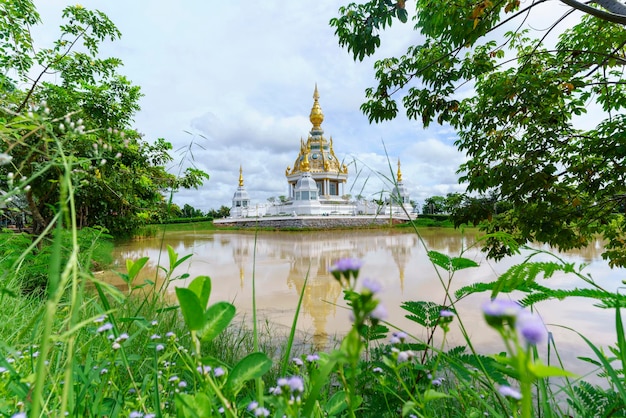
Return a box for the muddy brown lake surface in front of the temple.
[112,229,626,378]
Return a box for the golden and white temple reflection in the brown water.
[222,231,417,346]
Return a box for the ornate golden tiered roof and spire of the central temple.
[285,84,348,178]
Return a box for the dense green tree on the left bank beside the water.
[0,0,208,233]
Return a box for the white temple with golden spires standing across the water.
[230,85,412,218]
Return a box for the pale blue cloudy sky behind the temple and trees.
[34,0,576,211]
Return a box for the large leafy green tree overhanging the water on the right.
[331,0,626,265]
